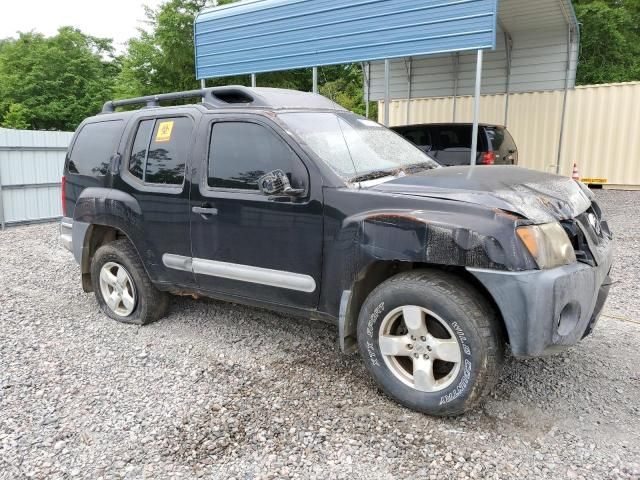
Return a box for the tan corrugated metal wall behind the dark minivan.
[379,82,640,186]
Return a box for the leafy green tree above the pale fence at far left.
[0,27,119,130]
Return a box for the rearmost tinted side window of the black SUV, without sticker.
[68,120,122,177]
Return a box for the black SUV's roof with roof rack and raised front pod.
[102,86,345,113]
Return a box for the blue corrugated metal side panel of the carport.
[194,0,497,79]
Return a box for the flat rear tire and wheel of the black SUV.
[91,239,169,325]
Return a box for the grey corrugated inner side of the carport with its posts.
[365,0,580,172]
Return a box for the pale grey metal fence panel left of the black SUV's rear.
[0,128,73,223]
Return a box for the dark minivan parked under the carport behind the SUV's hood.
[392,123,518,167]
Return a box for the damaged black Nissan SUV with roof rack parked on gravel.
[61,87,612,415]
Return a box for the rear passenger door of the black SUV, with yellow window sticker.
[114,109,198,286]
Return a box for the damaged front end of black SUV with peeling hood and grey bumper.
[327,167,612,357]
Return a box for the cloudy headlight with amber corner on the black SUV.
[516,222,576,270]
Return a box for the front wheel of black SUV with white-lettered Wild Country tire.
[358,270,504,416]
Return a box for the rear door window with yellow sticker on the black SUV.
[129,117,192,185]
